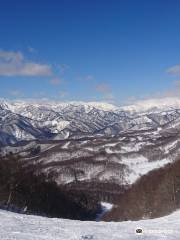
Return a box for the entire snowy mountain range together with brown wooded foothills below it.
[0,98,180,188]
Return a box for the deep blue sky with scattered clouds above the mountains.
[0,0,180,103]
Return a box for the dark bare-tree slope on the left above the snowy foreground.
[0,154,99,220]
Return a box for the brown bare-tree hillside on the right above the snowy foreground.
[104,159,180,221]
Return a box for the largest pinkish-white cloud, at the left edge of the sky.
[0,50,52,77]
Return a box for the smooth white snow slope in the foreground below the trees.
[0,210,180,240]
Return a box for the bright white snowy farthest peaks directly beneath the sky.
[0,97,180,112]
